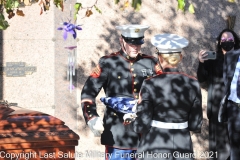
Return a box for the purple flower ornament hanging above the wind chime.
[58,22,82,40]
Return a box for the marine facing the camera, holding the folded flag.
[81,24,161,160]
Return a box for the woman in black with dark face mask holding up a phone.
[197,29,240,160]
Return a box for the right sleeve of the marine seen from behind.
[188,82,203,132]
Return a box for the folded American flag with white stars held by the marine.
[100,97,137,113]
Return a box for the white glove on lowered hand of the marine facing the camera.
[87,117,104,137]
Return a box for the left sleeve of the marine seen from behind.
[132,80,153,133]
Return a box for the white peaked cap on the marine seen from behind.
[151,33,189,53]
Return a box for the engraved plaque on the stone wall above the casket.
[1,62,37,77]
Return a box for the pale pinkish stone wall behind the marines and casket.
[0,0,240,160]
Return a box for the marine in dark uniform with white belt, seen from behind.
[131,34,203,160]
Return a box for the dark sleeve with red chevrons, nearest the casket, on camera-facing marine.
[81,57,108,123]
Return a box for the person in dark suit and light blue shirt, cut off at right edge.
[221,34,240,160]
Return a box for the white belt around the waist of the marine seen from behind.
[151,120,188,129]
